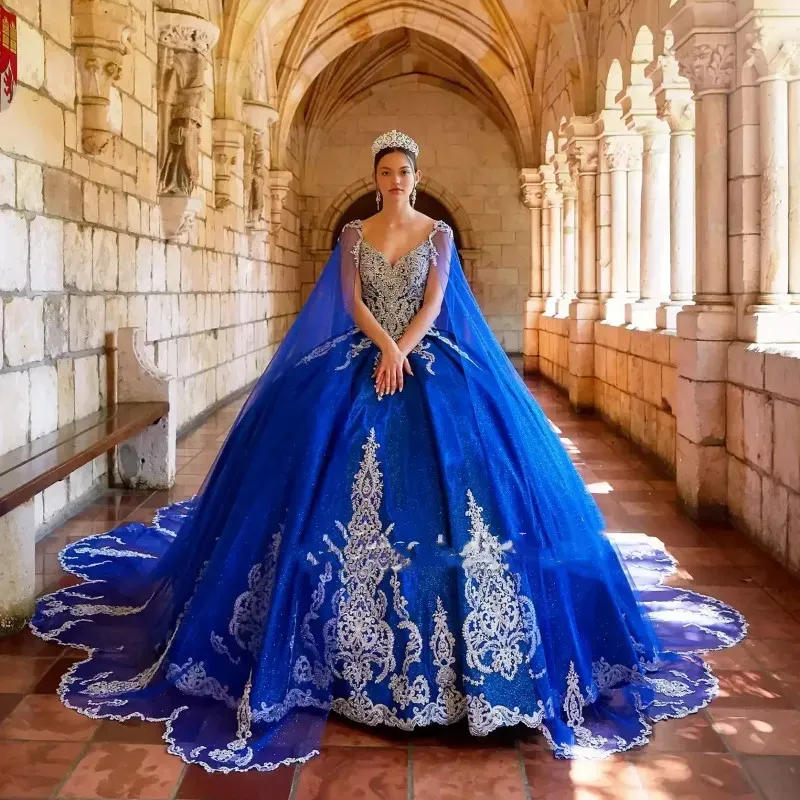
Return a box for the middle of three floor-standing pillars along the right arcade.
[567,125,600,411]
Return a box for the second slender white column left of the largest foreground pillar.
[629,118,670,328]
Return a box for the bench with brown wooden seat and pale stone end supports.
[0,328,176,635]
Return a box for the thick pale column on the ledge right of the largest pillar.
[745,25,800,342]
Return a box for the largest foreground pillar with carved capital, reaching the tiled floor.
[671,29,736,517]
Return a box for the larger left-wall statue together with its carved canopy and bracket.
[156,10,219,240]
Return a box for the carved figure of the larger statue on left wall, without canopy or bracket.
[158,48,206,196]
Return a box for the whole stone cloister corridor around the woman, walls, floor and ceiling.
[0,0,800,800]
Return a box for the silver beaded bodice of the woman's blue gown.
[349,220,448,339]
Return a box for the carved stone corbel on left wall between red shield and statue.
[72,0,133,155]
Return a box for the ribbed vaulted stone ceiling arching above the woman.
[218,0,599,164]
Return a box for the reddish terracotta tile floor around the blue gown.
[0,382,800,800]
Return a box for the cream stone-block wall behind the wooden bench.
[0,0,300,536]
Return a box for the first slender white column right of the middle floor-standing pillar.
[603,136,632,325]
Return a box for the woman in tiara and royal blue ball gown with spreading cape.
[33,131,744,771]
